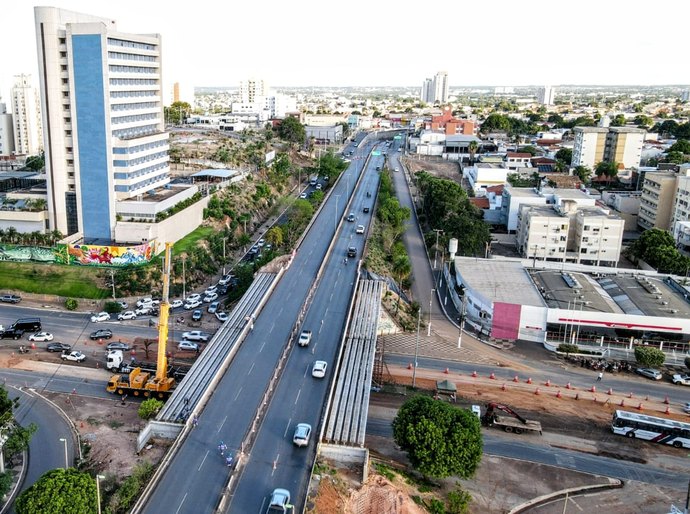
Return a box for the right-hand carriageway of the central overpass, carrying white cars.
[228,140,383,512]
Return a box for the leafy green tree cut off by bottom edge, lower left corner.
[14,468,98,514]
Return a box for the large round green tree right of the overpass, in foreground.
[393,396,482,478]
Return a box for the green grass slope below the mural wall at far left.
[0,262,110,299]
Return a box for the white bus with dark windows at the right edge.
[611,410,690,448]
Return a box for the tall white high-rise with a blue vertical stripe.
[35,7,177,241]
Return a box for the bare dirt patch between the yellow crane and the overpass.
[43,392,168,479]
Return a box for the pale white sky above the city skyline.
[0,0,690,100]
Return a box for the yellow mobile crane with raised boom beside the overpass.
[105,243,175,399]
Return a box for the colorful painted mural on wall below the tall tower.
[56,243,155,267]
